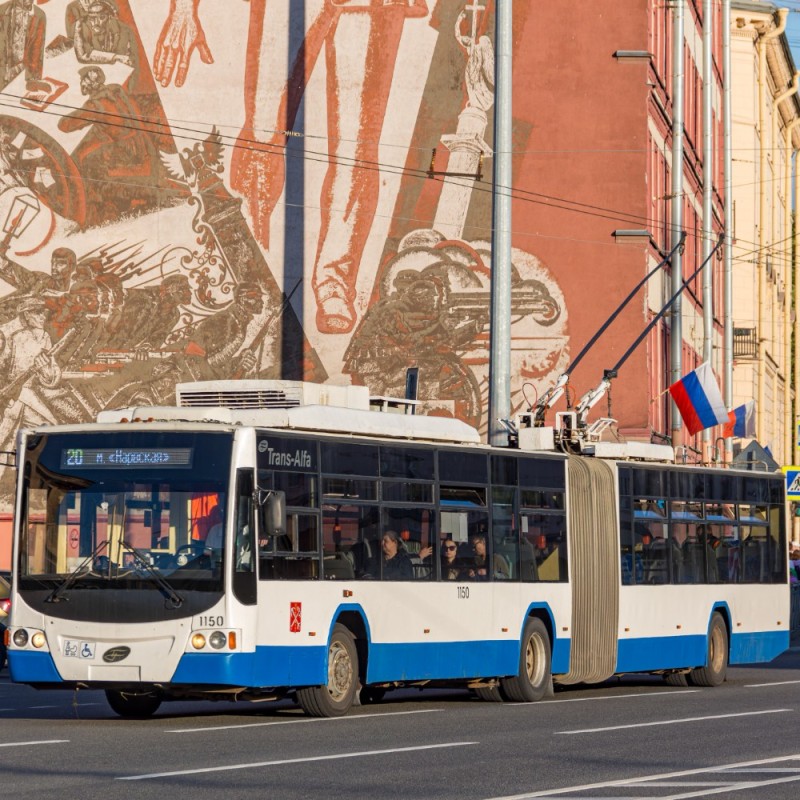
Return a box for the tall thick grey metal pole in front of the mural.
[488,0,514,447]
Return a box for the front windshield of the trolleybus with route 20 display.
[18,430,232,602]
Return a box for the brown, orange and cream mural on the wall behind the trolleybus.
[0,0,568,500]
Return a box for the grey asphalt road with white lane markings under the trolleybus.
[0,652,800,800]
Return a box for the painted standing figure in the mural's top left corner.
[0,0,47,89]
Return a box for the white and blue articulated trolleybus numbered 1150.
[8,381,789,717]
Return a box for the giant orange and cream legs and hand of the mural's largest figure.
[153,0,428,333]
